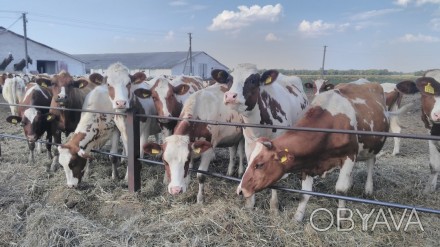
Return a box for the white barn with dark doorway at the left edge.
[0,27,86,75]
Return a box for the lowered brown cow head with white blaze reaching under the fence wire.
[237,138,294,198]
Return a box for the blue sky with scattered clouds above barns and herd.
[0,0,440,72]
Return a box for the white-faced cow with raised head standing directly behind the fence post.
[104,62,161,180]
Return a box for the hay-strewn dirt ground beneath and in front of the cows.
[0,84,440,247]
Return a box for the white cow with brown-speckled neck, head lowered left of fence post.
[58,84,119,188]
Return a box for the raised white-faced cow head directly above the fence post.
[105,63,151,112]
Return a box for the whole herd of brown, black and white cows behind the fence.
[0,63,440,221]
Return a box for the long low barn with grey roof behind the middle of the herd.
[75,51,228,79]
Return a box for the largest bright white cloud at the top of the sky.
[208,4,282,31]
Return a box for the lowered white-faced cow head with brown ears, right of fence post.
[143,135,212,195]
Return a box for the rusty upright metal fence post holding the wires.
[126,109,141,192]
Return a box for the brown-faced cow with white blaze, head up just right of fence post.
[149,75,203,138]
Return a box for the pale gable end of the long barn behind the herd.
[172,53,228,79]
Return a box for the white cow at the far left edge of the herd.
[2,74,26,116]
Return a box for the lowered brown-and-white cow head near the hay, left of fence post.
[58,144,90,188]
